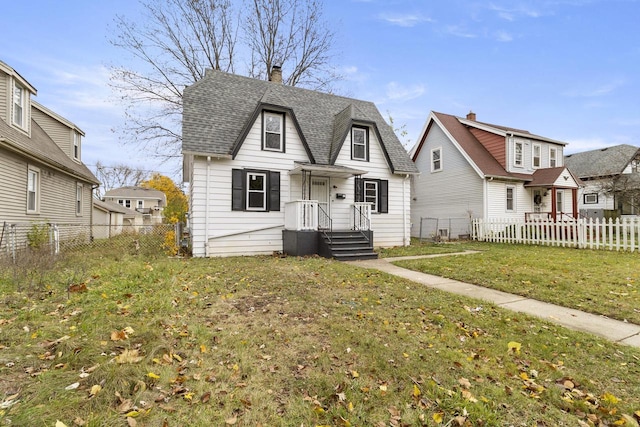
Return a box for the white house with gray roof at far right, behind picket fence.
[564,144,640,218]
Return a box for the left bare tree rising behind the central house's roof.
[111,0,238,159]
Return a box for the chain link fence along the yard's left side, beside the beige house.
[0,221,189,263]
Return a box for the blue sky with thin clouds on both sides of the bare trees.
[0,0,640,178]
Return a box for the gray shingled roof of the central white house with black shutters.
[182,70,418,173]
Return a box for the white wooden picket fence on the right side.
[472,218,640,252]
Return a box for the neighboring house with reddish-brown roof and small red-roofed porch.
[410,112,580,238]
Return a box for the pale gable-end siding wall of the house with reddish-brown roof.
[412,123,485,238]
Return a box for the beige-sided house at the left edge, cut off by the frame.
[0,61,99,247]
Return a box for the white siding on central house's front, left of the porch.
[189,111,309,256]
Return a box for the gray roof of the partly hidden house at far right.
[564,144,638,179]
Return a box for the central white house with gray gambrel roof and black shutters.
[182,67,418,259]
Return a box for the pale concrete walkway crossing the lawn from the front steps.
[350,251,640,347]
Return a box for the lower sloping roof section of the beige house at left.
[0,120,99,184]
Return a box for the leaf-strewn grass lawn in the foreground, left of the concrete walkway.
[0,251,640,427]
